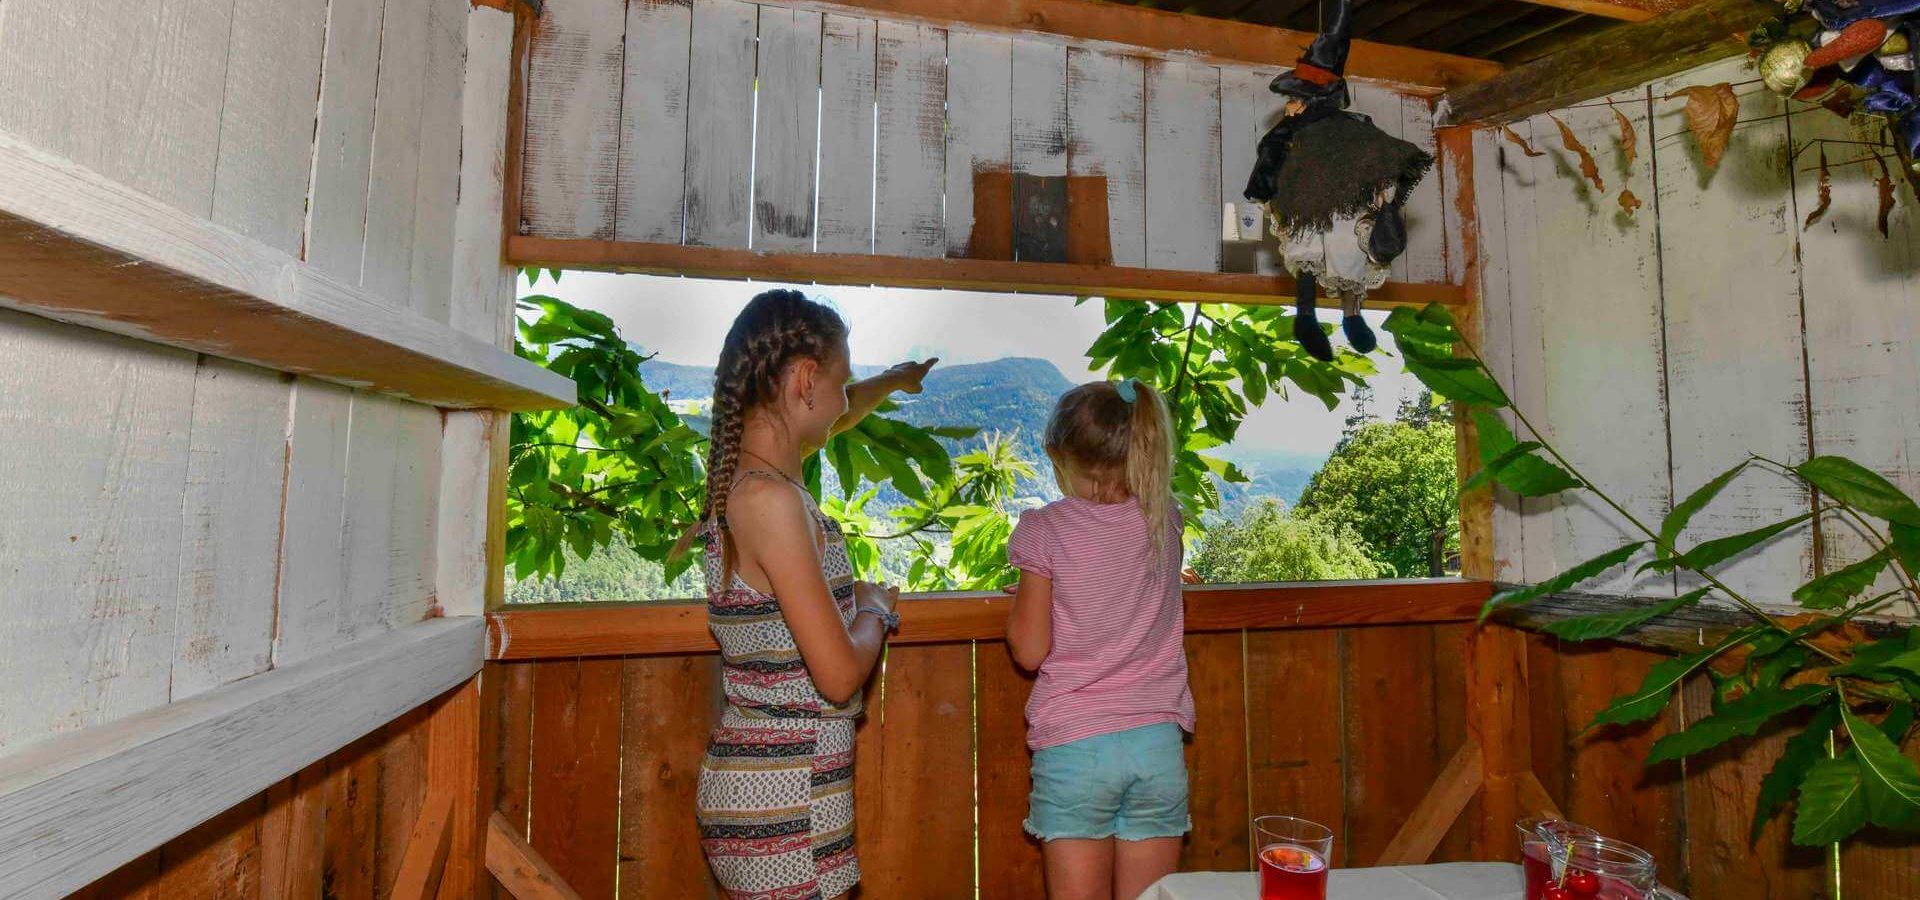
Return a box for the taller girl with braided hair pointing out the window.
[676,290,935,900]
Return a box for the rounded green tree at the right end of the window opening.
[1298,420,1459,578]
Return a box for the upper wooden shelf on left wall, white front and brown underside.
[0,134,574,411]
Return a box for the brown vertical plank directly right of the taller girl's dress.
[854,643,973,896]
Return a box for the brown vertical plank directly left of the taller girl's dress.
[618,656,722,898]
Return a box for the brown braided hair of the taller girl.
[674,290,847,585]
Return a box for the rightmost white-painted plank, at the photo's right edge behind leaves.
[1791,105,1920,591]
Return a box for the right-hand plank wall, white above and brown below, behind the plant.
[1475,52,1920,900]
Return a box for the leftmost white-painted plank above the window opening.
[520,0,626,238]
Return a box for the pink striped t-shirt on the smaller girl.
[1006,497,1194,750]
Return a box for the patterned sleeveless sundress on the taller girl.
[697,470,860,900]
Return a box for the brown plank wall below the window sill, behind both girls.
[482,626,1465,900]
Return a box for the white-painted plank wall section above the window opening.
[520,0,1446,282]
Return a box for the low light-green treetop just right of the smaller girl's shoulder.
[1188,499,1392,583]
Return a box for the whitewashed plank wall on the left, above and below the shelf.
[0,0,480,750]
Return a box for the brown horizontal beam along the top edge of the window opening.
[507,234,1461,309]
